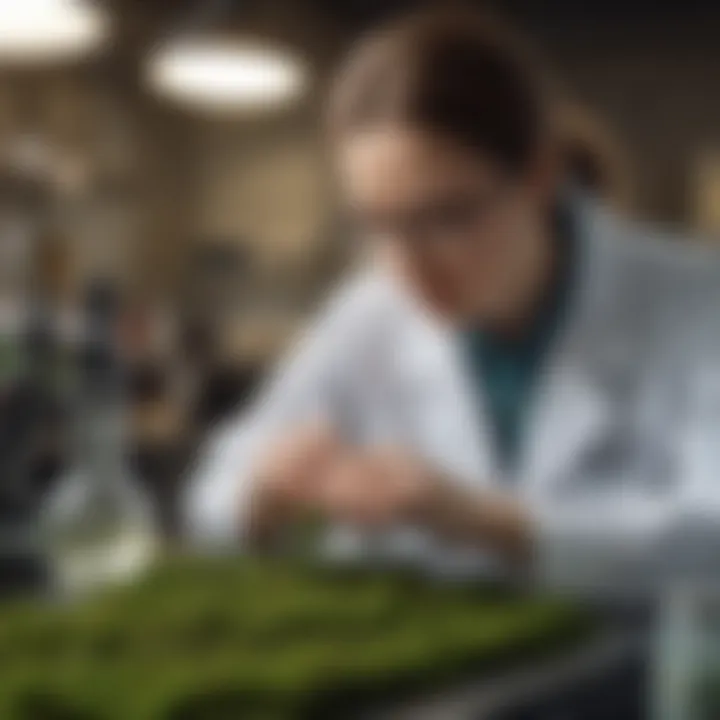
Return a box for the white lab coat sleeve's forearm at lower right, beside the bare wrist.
[533,496,720,599]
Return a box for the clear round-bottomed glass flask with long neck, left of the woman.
[44,288,158,594]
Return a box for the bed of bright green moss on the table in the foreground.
[0,558,593,720]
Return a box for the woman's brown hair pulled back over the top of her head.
[329,7,547,172]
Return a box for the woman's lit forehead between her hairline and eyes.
[337,127,497,206]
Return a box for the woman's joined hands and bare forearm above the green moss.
[251,434,532,563]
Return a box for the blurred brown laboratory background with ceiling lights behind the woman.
[0,0,720,535]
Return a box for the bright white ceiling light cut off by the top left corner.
[0,0,109,63]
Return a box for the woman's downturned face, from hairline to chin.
[338,128,549,322]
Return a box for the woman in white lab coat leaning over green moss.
[188,13,720,591]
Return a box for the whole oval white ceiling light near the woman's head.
[148,37,307,113]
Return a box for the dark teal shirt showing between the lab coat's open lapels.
[461,208,577,471]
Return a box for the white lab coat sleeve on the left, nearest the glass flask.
[183,278,376,549]
